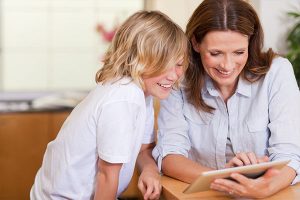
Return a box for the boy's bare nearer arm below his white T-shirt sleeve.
[94,159,122,200]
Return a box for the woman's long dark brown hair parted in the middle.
[185,0,275,112]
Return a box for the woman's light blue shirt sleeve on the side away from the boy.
[268,58,300,184]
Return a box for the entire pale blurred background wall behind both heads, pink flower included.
[0,0,300,91]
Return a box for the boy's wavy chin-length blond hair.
[96,11,190,87]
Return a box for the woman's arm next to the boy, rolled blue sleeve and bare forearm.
[152,90,211,183]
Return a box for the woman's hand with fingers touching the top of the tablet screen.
[225,152,269,168]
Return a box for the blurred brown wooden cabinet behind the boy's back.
[0,112,69,200]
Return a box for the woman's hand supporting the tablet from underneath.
[210,168,280,198]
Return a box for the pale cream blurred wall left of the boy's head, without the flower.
[0,0,144,91]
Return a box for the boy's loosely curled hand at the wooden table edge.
[138,168,161,200]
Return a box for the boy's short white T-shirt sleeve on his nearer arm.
[96,101,140,163]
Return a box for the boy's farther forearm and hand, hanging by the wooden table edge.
[137,143,161,199]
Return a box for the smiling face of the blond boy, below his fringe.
[143,60,183,99]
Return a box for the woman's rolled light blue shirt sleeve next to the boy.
[152,90,191,170]
